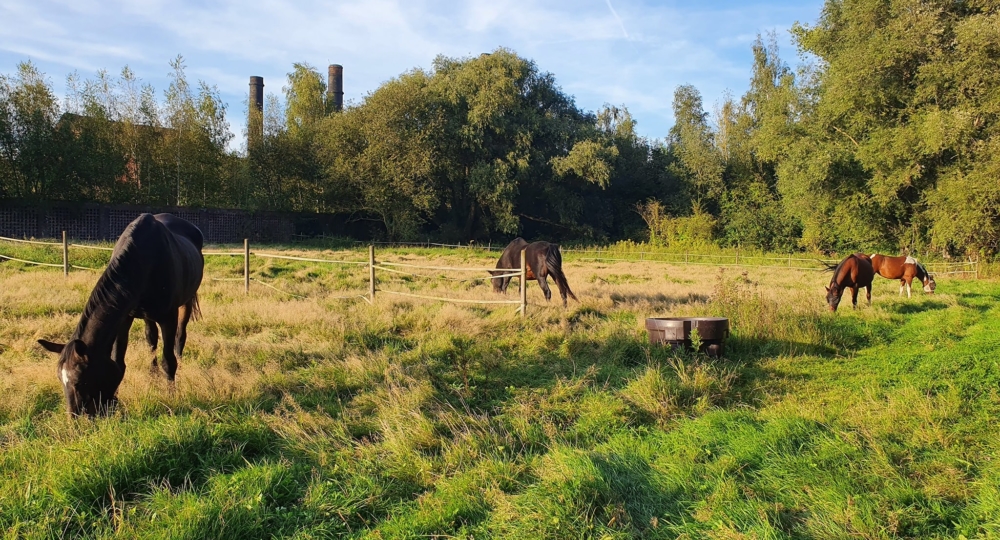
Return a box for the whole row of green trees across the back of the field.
[0,0,1000,255]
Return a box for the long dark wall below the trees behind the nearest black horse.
[0,200,380,244]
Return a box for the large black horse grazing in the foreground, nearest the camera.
[38,214,205,416]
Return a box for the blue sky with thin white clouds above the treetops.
[0,0,823,148]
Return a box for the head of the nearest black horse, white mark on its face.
[38,339,122,417]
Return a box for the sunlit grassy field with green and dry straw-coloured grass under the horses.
[0,246,1000,540]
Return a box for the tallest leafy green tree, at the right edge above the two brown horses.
[794,0,1000,252]
